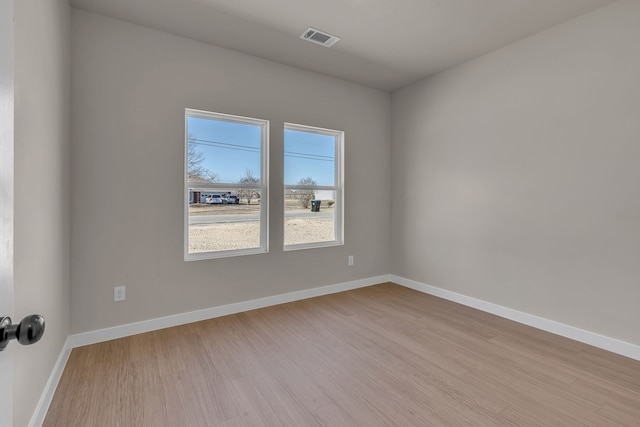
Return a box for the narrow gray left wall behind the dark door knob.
[13,0,71,426]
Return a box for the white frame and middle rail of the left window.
[183,108,269,261]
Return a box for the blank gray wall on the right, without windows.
[392,1,640,344]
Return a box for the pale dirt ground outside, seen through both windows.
[189,200,334,253]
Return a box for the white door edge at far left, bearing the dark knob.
[0,0,15,425]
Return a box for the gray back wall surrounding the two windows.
[71,10,391,333]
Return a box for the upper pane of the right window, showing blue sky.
[284,129,336,186]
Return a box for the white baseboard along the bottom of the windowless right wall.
[389,274,640,360]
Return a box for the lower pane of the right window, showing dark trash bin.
[284,189,336,246]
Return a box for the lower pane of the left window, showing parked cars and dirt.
[188,188,261,254]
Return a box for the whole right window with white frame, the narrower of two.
[284,123,344,250]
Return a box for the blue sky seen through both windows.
[187,117,335,185]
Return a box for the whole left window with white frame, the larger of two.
[184,109,269,261]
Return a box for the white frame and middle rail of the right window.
[282,122,345,252]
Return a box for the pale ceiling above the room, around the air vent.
[70,0,616,91]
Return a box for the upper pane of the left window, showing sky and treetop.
[187,116,262,184]
